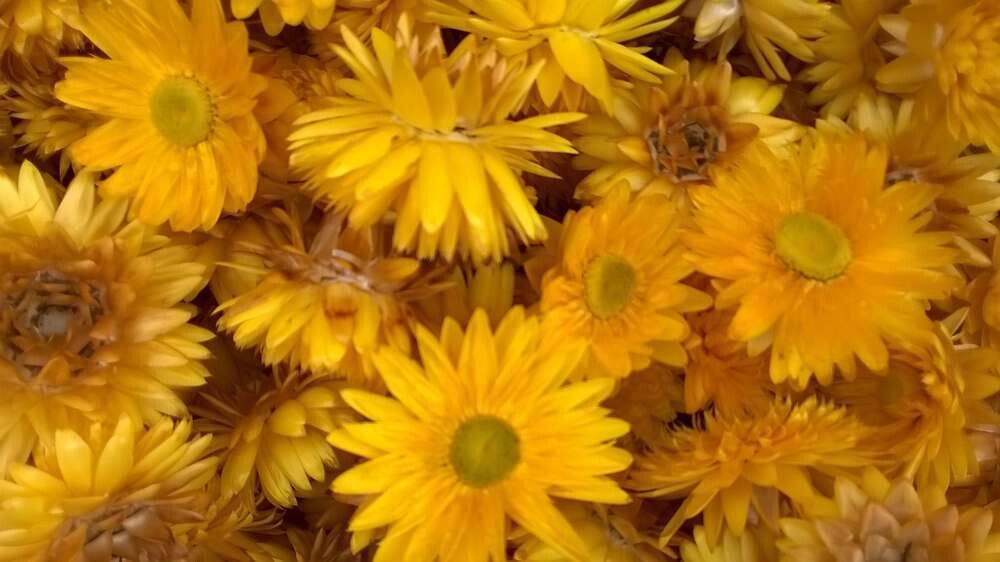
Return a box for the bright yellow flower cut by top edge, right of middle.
[427,0,681,113]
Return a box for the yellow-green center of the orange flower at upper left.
[149,76,214,147]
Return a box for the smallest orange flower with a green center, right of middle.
[540,186,711,378]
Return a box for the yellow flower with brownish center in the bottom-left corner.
[0,416,218,562]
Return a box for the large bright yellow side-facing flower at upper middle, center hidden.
[290,25,581,261]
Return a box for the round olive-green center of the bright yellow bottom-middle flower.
[451,416,521,488]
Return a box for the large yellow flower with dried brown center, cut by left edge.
[0,162,211,475]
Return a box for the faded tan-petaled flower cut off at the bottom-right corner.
[777,469,1000,562]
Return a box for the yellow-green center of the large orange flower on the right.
[774,211,851,281]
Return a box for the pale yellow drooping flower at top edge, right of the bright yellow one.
[685,0,830,80]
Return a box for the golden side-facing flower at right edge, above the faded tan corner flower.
[825,326,1000,487]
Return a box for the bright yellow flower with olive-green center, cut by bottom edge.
[329,308,632,562]
